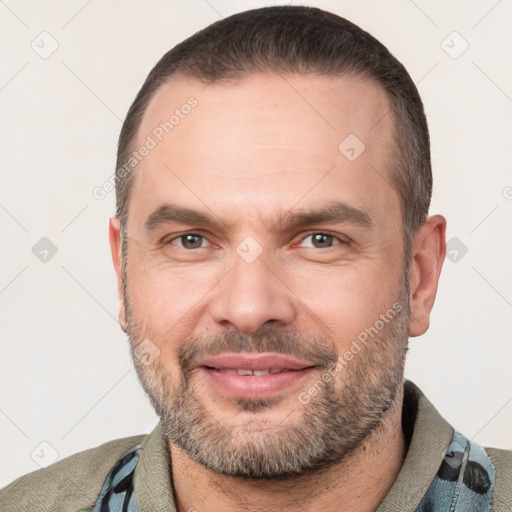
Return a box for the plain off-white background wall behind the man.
[0,0,512,487]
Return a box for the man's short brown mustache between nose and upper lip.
[178,330,338,375]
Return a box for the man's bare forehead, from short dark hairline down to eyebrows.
[130,74,397,230]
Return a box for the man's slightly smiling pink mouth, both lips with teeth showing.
[196,352,318,399]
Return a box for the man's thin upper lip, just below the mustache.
[196,352,316,370]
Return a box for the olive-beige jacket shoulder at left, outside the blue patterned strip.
[0,435,147,512]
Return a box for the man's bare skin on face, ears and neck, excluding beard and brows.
[110,74,446,512]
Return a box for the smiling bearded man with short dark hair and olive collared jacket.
[0,7,512,512]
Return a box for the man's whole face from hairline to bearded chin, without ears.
[117,75,408,478]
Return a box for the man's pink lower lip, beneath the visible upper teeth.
[198,366,314,398]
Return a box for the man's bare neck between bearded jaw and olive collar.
[170,388,406,512]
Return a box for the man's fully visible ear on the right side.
[409,215,446,337]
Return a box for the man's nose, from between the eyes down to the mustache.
[210,247,297,333]
